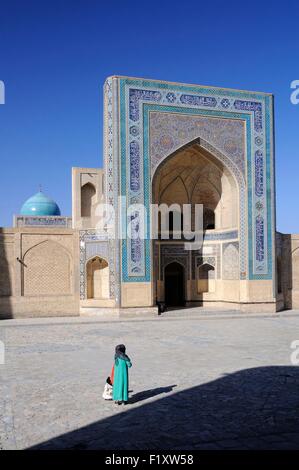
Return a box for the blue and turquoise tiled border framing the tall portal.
[119,78,274,282]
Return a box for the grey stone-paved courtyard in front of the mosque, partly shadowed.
[0,312,299,450]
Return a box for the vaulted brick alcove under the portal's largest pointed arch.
[152,139,243,308]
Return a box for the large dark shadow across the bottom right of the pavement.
[32,366,299,450]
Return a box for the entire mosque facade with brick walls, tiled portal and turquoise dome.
[0,76,299,318]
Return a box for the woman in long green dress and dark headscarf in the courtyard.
[113,344,132,405]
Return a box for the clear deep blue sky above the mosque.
[0,0,299,233]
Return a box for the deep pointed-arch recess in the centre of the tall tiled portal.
[152,139,246,305]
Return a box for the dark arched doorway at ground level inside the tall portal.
[164,262,185,307]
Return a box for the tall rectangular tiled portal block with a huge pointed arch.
[105,77,276,311]
